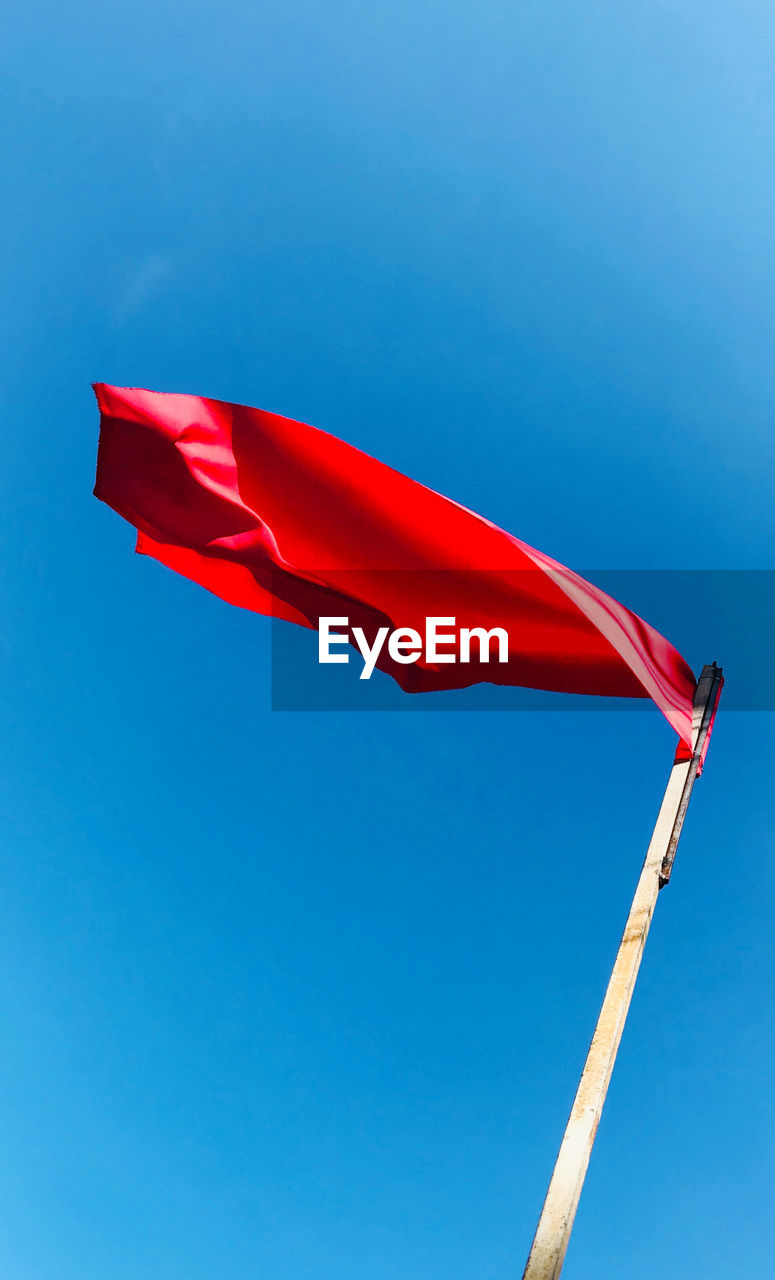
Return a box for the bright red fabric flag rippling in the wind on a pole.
[95,384,696,744]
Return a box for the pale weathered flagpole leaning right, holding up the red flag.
[523,663,722,1280]
